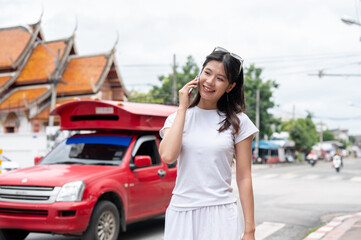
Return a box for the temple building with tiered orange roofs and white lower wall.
[0,20,129,167]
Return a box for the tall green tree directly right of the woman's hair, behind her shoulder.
[244,64,281,138]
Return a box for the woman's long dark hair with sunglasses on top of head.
[189,51,246,134]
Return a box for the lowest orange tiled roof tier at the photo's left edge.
[0,87,48,110]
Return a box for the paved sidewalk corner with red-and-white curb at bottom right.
[303,212,361,240]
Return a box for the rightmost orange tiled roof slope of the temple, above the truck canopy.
[57,55,107,96]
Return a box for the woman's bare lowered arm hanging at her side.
[236,136,255,240]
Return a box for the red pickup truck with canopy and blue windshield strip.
[0,100,177,240]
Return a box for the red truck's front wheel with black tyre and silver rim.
[82,201,120,240]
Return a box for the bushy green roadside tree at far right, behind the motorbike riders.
[281,113,318,152]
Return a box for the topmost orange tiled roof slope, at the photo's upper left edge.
[0,27,31,68]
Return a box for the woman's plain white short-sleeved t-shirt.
[160,106,258,209]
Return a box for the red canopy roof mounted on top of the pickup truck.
[50,100,178,131]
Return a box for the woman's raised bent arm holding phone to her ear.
[159,79,197,163]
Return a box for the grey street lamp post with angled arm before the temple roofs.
[21,26,60,126]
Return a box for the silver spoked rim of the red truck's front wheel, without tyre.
[97,211,116,240]
